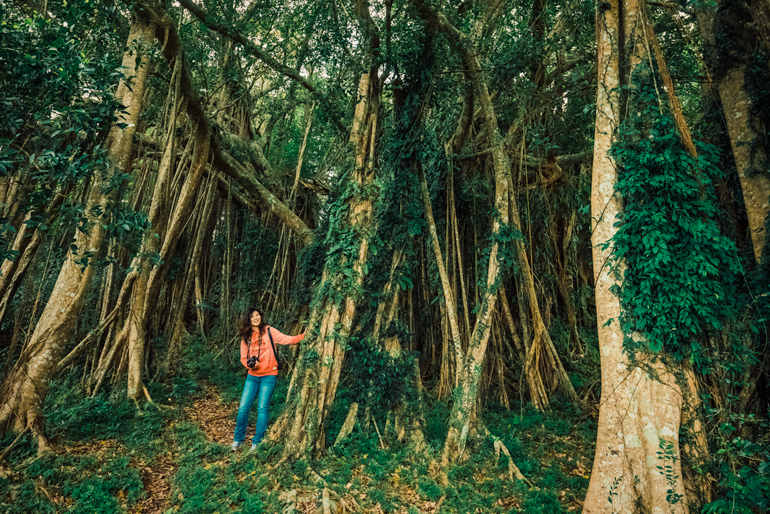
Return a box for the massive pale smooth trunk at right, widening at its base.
[583,0,687,508]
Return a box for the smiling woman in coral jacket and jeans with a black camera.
[230,308,305,451]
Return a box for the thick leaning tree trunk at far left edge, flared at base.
[0,10,156,451]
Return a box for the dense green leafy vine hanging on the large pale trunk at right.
[610,64,741,368]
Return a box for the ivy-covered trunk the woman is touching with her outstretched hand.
[268,67,381,455]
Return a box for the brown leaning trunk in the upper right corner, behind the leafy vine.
[695,2,770,262]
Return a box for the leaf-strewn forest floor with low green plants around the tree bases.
[0,336,596,514]
